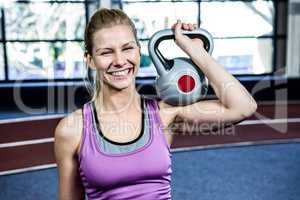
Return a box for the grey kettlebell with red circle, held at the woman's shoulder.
[148,28,213,106]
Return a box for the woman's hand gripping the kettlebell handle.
[171,20,205,55]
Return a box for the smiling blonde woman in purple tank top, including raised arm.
[55,9,256,200]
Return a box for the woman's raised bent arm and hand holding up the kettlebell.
[165,22,257,131]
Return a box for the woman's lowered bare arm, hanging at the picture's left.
[54,112,85,200]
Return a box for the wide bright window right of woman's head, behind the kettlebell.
[122,0,282,77]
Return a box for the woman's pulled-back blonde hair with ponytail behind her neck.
[84,8,140,100]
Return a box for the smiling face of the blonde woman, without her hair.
[88,25,140,90]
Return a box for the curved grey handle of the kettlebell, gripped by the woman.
[148,28,213,75]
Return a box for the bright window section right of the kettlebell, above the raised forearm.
[200,1,274,74]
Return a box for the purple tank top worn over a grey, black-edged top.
[79,99,172,200]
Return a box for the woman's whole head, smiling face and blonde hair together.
[84,9,140,99]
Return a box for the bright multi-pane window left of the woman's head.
[0,0,99,82]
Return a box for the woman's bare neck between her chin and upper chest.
[95,83,140,114]
